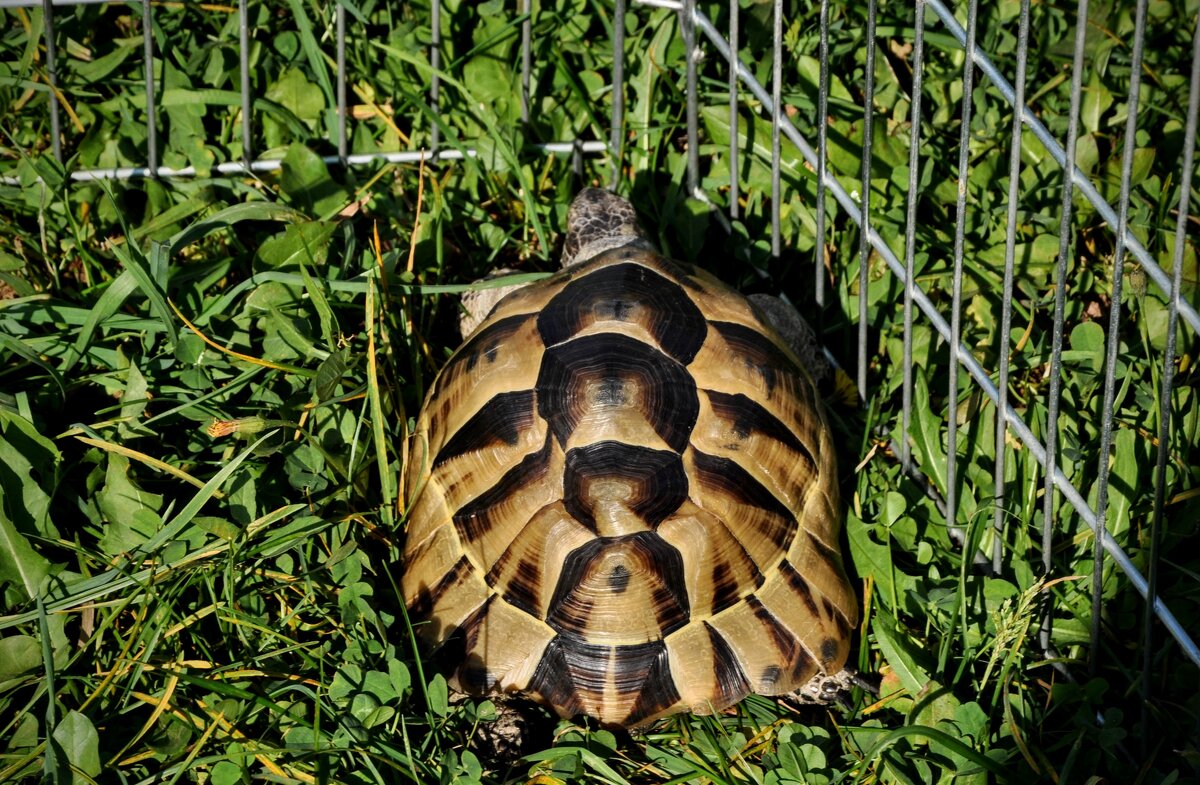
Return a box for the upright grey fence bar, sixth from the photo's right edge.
[900,0,925,472]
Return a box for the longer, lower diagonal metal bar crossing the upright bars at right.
[696,6,1200,666]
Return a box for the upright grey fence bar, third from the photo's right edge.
[1038,0,1087,651]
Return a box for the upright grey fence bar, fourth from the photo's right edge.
[991,0,1030,575]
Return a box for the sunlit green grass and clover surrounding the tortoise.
[0,0,1200,785]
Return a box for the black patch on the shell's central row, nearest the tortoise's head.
[538,263,708,365]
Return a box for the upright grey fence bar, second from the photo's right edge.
[1087,0,1146,676]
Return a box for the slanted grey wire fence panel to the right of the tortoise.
[648,0,1200,686]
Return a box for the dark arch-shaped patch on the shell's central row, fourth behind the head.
[546,532,690,637]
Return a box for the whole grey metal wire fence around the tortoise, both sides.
[9,0,1200,715]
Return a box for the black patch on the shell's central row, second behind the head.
[536,332,700,453]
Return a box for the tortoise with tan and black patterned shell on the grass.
[401,188,857,727]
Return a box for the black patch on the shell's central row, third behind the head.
[563,442,688,531]
